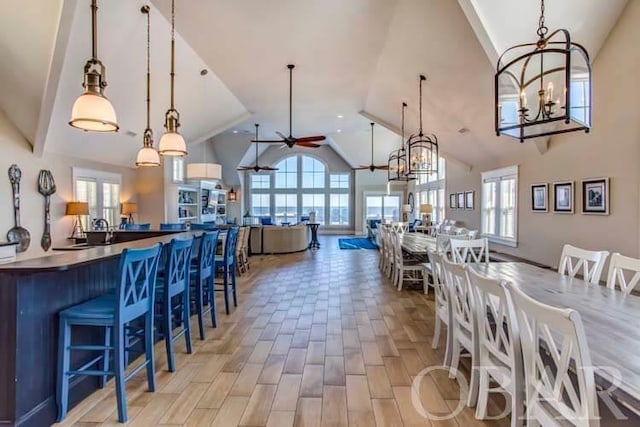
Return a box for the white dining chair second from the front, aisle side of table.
[468,268,524,427]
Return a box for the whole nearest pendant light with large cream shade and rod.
[69,0,118,132]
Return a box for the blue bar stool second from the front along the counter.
[156,237,194,372]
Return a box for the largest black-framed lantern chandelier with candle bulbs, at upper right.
[495,0,591,142]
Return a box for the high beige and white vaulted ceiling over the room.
[0,0,627,169]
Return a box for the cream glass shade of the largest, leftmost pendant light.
[69,91,118,132]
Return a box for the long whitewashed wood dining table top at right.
[469,262,640,409]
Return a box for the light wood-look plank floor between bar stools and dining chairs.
[53,237,508,427]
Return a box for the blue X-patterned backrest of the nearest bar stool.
[116,244,162,324]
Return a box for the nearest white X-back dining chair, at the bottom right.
[506,284,600,427]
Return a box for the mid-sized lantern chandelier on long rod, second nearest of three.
[407,74,438,177]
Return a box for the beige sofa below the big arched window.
[250,225,309,254]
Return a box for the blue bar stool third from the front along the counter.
[191,230,220,340]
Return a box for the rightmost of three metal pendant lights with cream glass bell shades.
[158,0,187,157]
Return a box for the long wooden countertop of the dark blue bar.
[0,230,203,273]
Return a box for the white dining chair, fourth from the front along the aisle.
[429,250,453,366]
